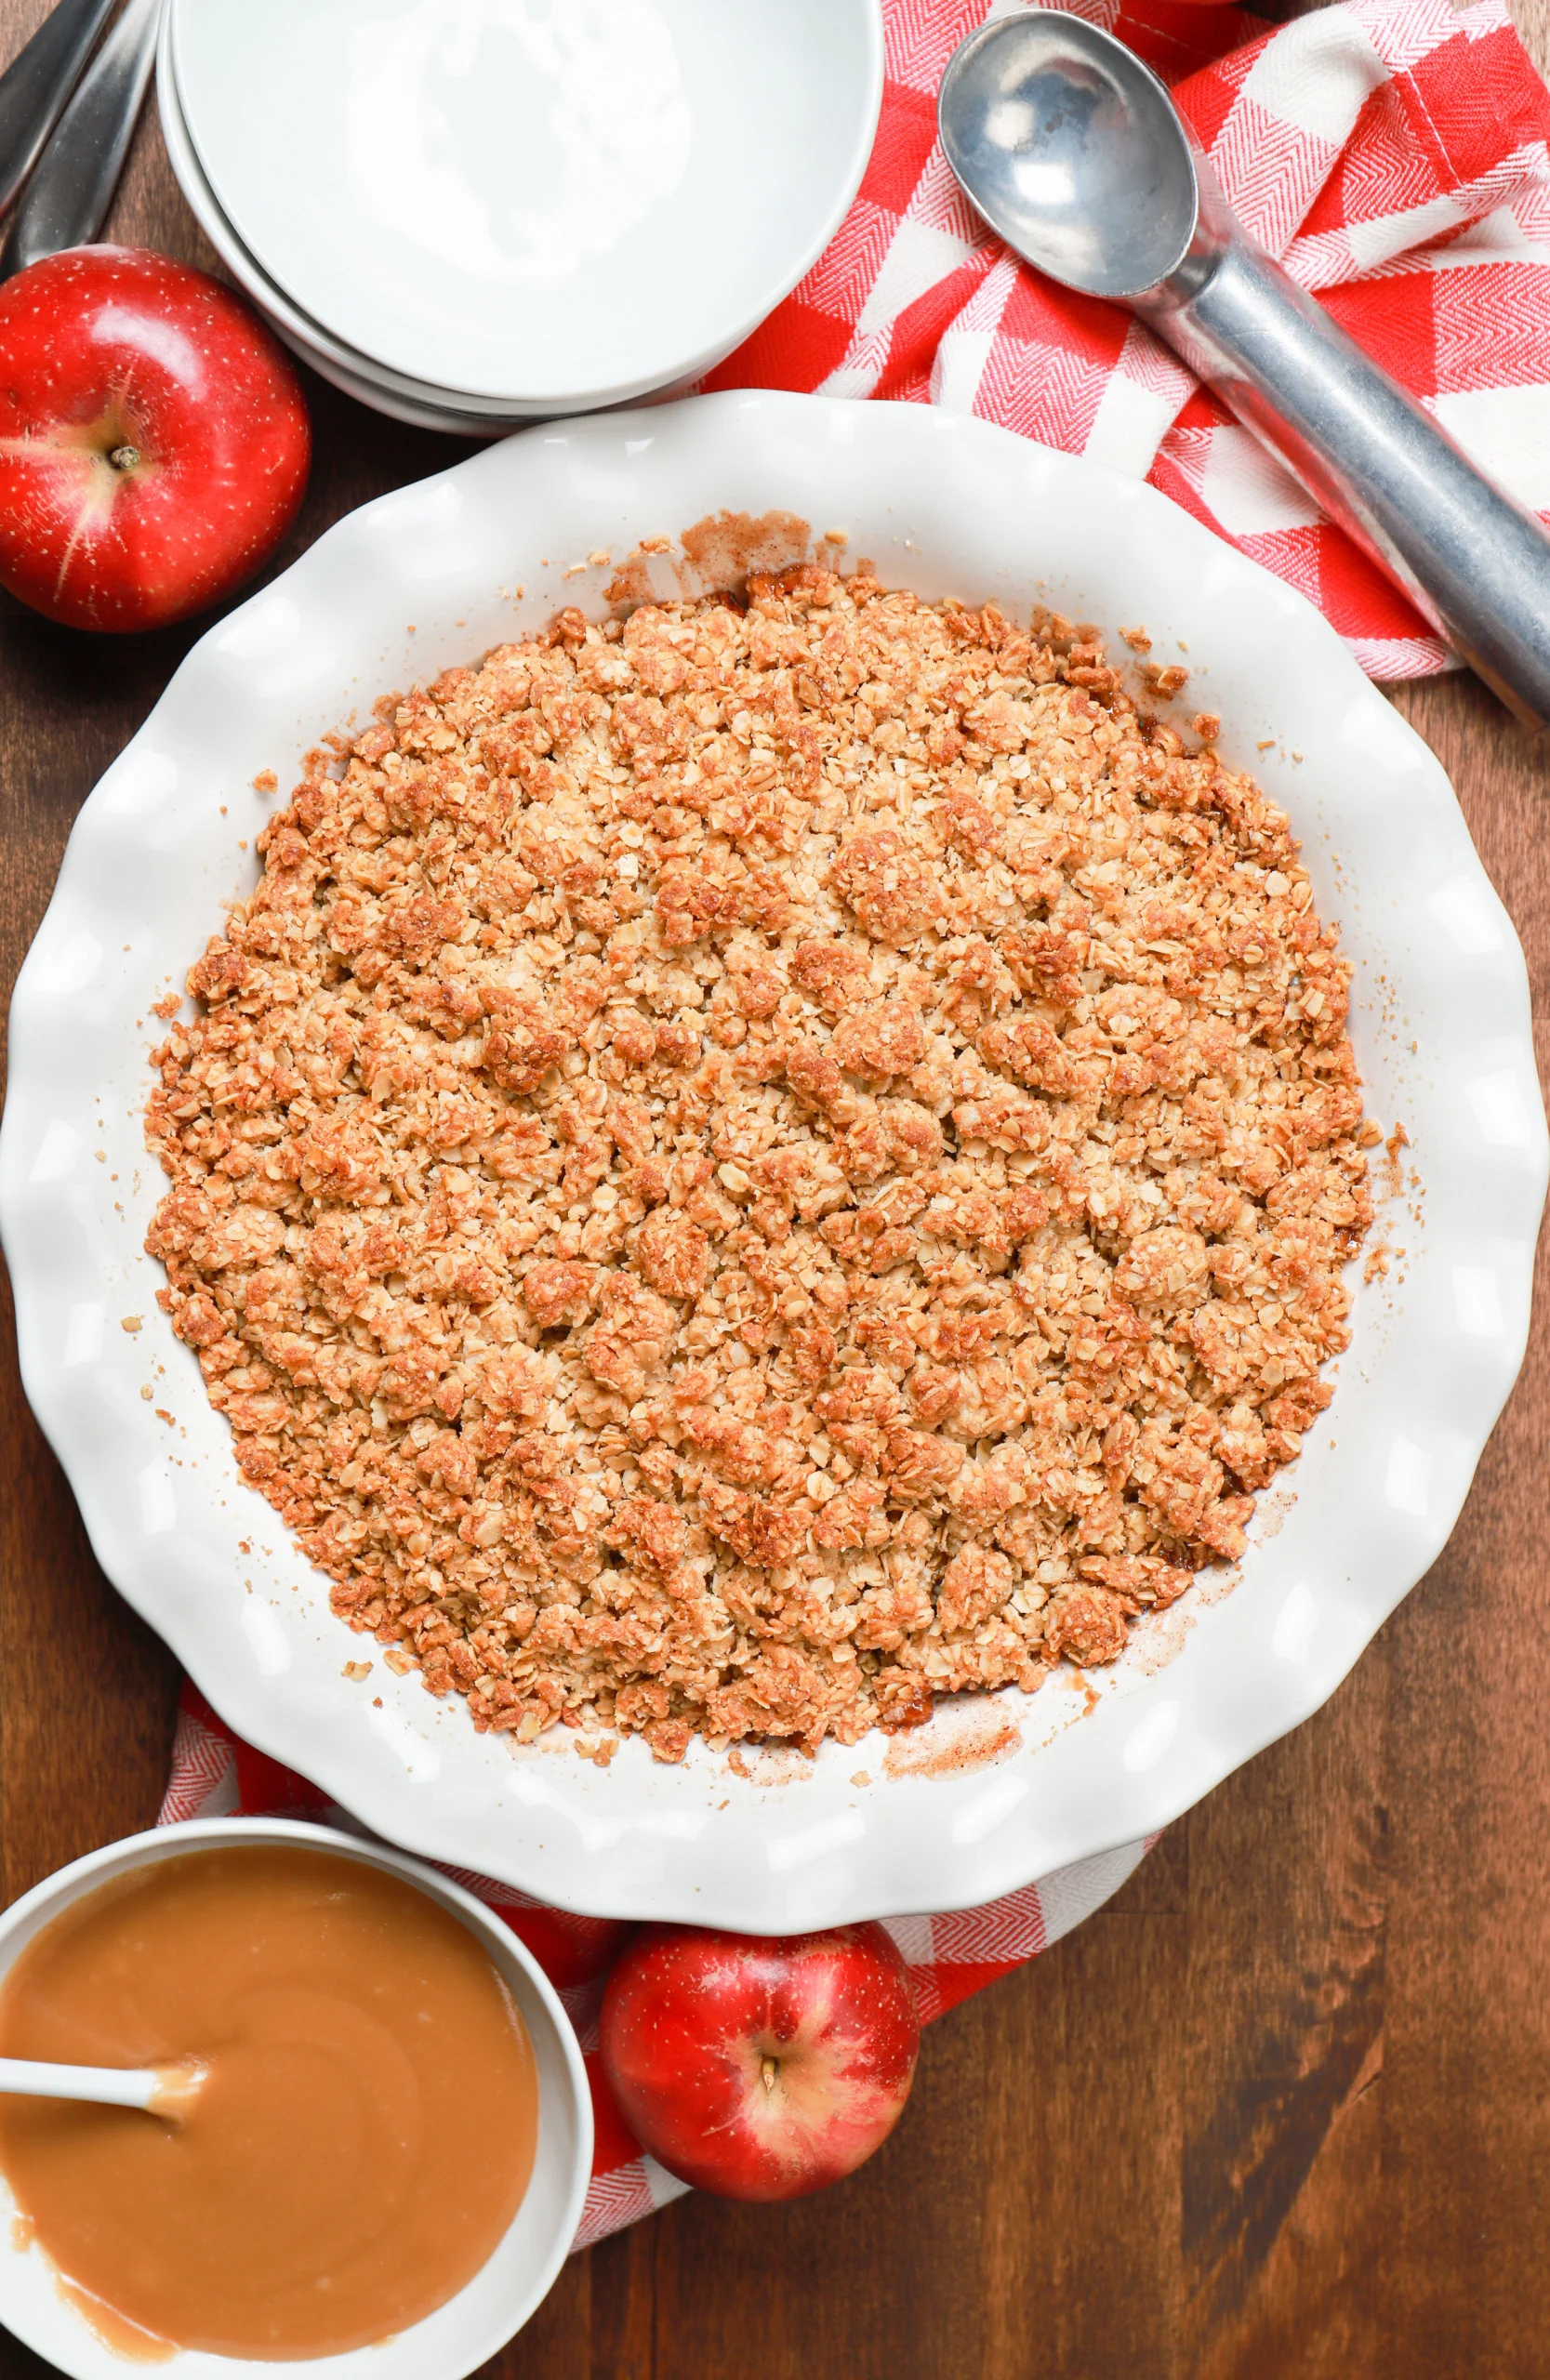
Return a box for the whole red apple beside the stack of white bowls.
[0,247,311,628]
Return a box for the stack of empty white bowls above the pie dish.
[157,0,883,435]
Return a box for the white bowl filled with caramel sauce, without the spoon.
[0,1818,593,2380]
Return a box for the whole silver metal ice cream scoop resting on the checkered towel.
[938,7,1550,726]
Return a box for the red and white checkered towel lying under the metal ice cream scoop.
[705,0,1550,679]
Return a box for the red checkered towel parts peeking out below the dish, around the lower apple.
[160,1685,1146,2247]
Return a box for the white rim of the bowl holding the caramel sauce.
[0,1816,593,2380]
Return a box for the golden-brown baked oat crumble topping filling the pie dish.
[148,566,1376,1761]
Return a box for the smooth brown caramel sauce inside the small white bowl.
[0,1844,538,2361]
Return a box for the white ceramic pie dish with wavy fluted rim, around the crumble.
[0,392,1547,1930]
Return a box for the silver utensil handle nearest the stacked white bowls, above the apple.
[0,0,162,281]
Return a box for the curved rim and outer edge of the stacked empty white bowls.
[160,0,886,416]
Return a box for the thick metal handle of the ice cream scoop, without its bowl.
[1147,157,1550,726]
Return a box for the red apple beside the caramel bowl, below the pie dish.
[603,1925,921,2199]
